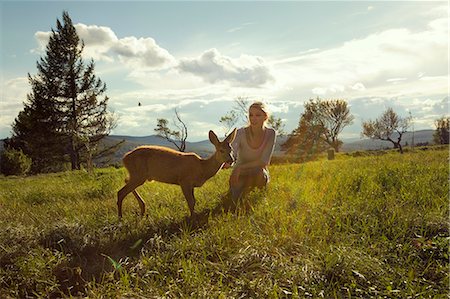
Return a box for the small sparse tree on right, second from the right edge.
[362,108,411,153]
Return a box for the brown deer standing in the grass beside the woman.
[117,128,236,219]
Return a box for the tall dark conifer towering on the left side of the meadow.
[10,11,116,172]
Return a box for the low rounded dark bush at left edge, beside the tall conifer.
[0,149,31,175]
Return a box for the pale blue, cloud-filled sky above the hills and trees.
[0,0,449,141]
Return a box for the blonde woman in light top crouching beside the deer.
[225,102,276,202]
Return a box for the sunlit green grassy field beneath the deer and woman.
[0,150,449,298]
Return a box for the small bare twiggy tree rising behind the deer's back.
[155,109,188,152]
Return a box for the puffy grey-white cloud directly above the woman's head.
[178,49,274,87]
